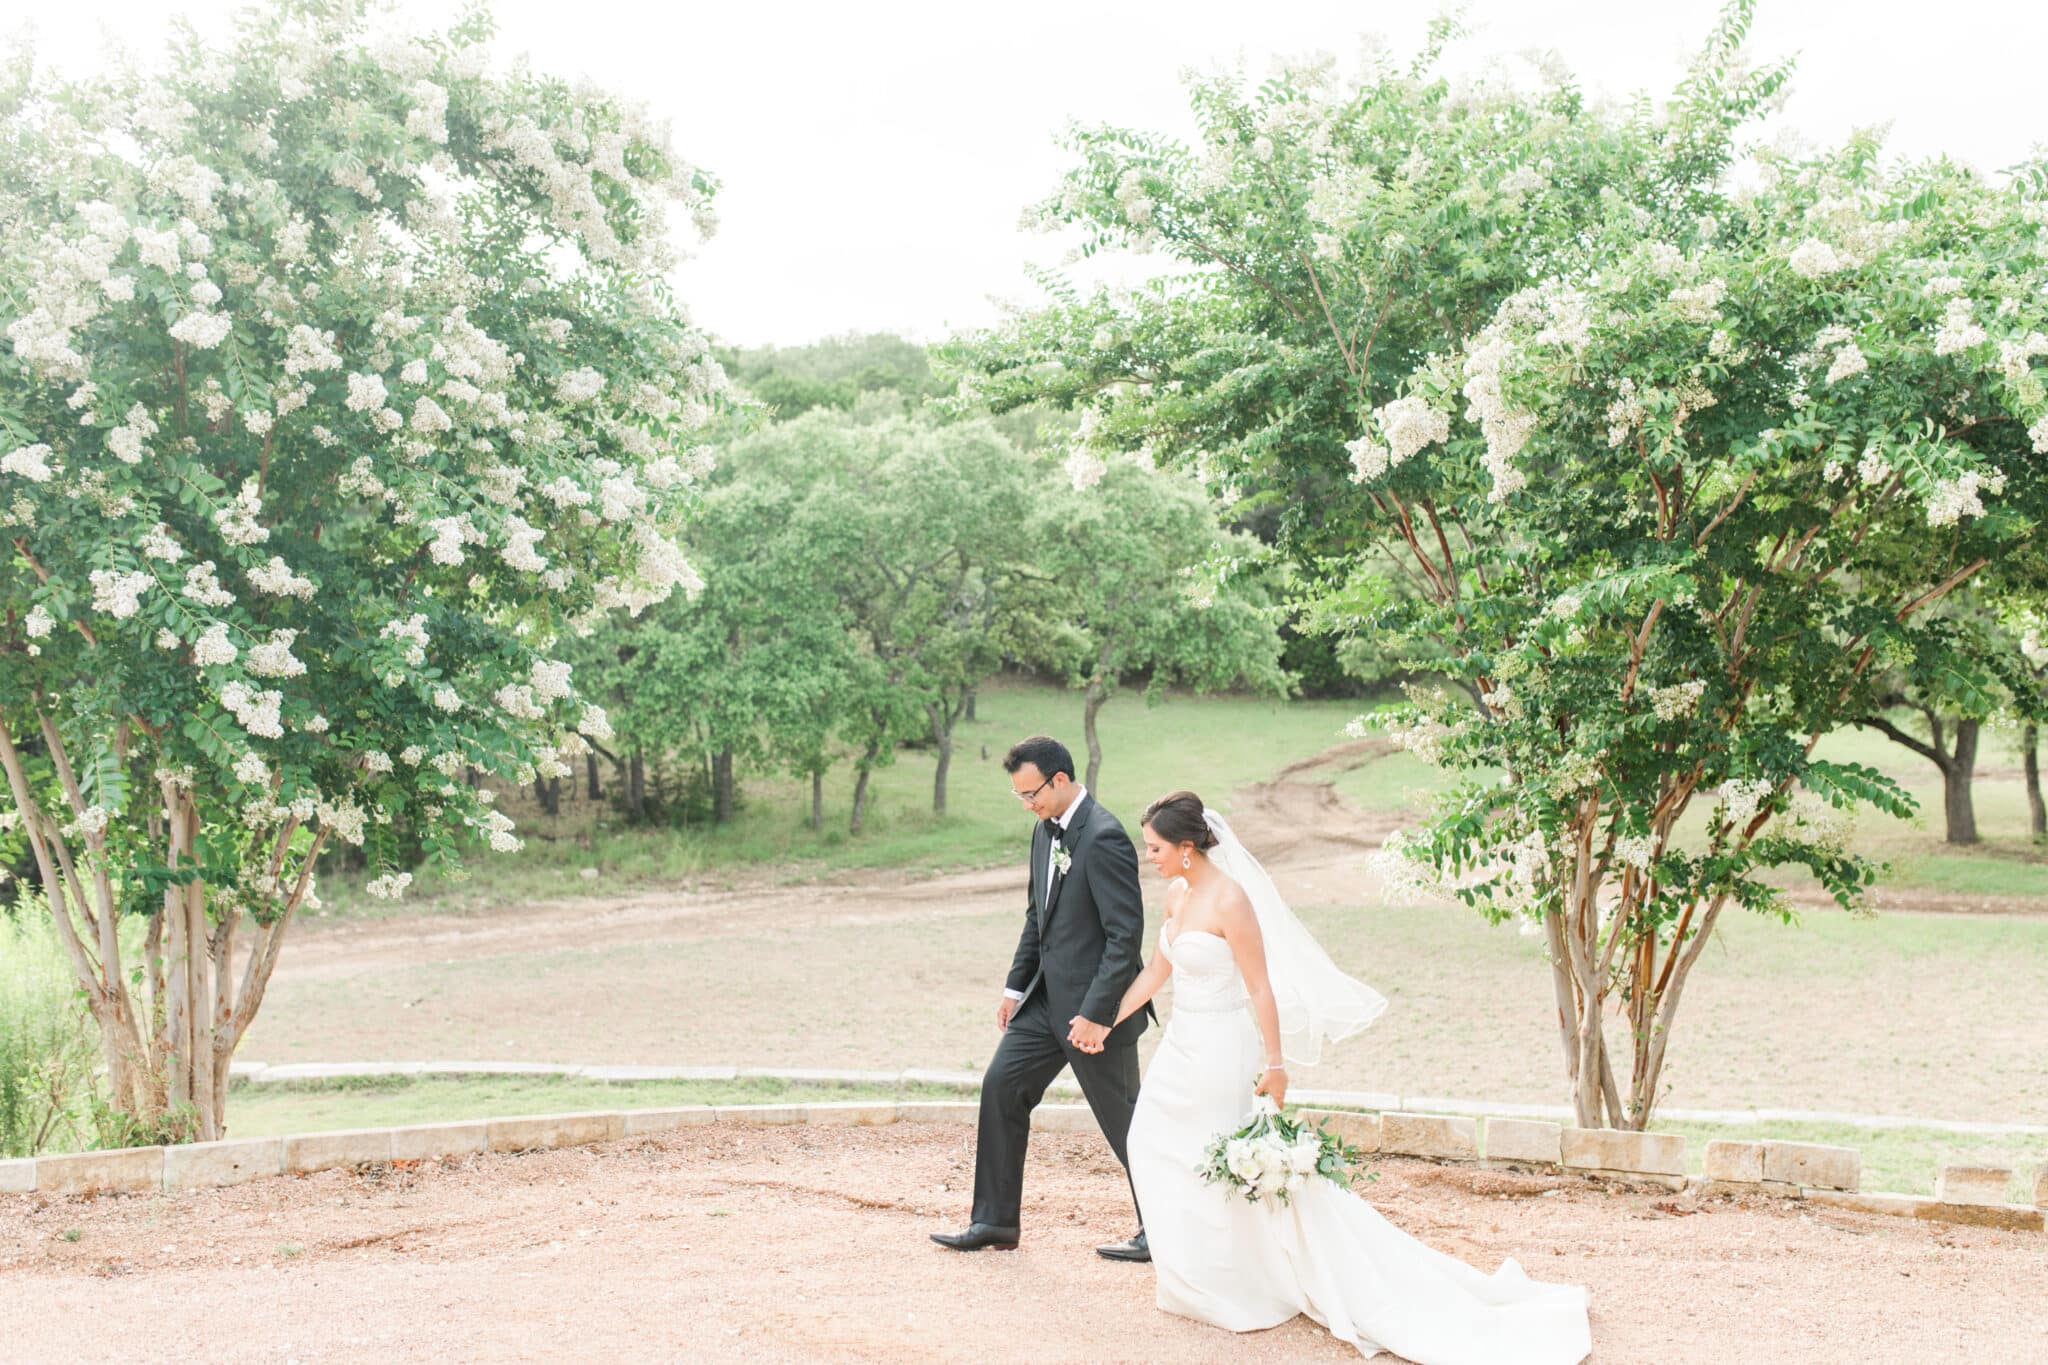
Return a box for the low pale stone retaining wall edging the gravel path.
[0,1099,2048,1232]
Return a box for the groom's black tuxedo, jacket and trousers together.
[975,796,1151,1228]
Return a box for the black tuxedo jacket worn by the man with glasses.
[1006,796,1151,1044]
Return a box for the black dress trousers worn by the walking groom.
[975,986,1139,1228]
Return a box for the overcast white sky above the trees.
[16,0,2048,344]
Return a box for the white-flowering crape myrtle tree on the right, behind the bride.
[950,4,2048,1128]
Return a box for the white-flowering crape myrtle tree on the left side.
[0,0,723,1138]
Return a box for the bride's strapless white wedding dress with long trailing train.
[1128,925,1593,1365]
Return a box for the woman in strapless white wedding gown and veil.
[1073,792,1591,1365]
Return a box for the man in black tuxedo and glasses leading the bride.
[932,735,1151,1261]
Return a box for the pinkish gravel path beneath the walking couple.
[0,1126,2048,1365]
